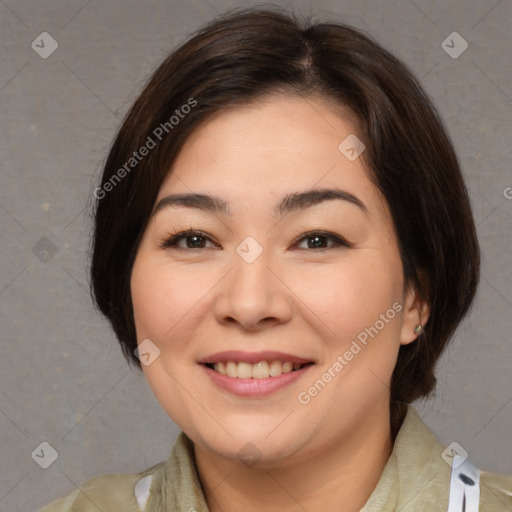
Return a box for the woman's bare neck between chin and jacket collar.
[195,404,393,512]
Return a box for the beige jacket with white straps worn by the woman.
[40,406,512,512]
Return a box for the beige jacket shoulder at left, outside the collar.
[39,462,164,512]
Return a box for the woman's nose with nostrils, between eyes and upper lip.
[213,246,293,331]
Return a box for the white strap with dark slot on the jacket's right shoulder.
[448,455,480,512]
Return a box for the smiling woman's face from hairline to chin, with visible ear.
[131,96,424,466]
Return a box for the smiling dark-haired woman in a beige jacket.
[41,5,512,512]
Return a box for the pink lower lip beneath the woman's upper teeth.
[201,364,313,397]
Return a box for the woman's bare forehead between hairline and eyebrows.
[157,95,384,216]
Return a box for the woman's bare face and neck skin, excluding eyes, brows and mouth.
[131,96,428,512]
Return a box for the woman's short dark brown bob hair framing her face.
[91,8,480,420]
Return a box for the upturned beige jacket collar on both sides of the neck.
[148,405,451,512]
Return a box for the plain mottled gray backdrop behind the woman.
[0,0,512,512]
